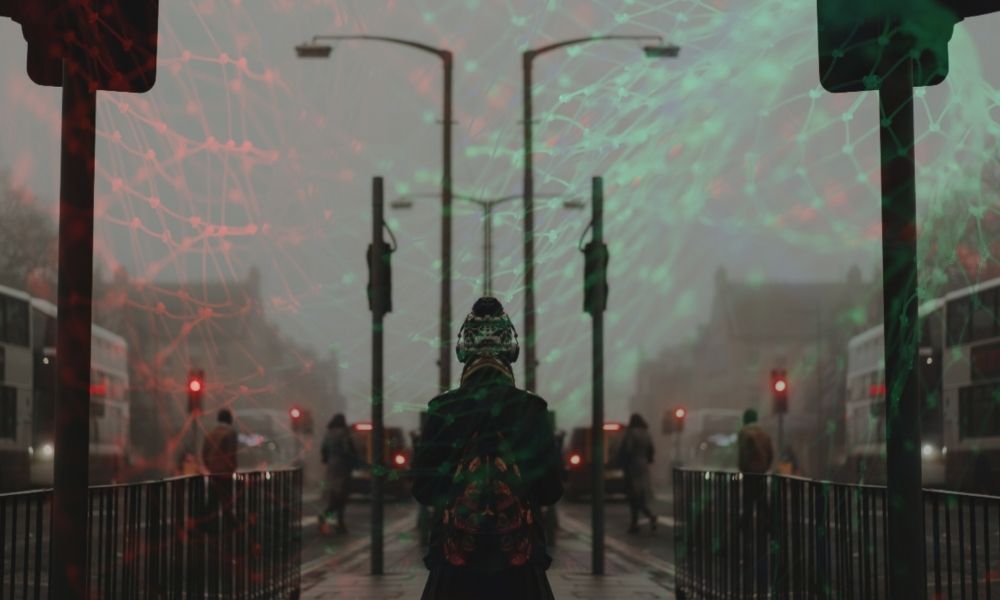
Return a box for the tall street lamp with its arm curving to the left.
[295,35,453,392]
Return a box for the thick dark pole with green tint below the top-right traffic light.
[878,59,927,600]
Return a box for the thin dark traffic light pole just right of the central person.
[590,177,607,575]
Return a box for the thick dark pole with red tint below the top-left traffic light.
[50,58,97,600]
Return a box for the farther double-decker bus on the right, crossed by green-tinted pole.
[844,300,951,486]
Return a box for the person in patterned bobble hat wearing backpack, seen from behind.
[412,297,562,600]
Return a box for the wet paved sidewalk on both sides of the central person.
[302,512,673,600]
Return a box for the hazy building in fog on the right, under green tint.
[633,268,881,476]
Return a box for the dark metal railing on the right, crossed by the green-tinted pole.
[674,469,1000,600]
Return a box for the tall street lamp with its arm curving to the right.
[521,35,680,390]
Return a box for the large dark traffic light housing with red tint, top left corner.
[0,0,159,92]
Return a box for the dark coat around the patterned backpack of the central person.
[411,369,562,600]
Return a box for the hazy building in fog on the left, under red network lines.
[95,269,344,474]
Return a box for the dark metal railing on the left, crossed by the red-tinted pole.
[0,470,302,600]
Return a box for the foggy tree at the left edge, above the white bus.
[0,171,58,299]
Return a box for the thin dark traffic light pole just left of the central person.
[371,177,386,575]
